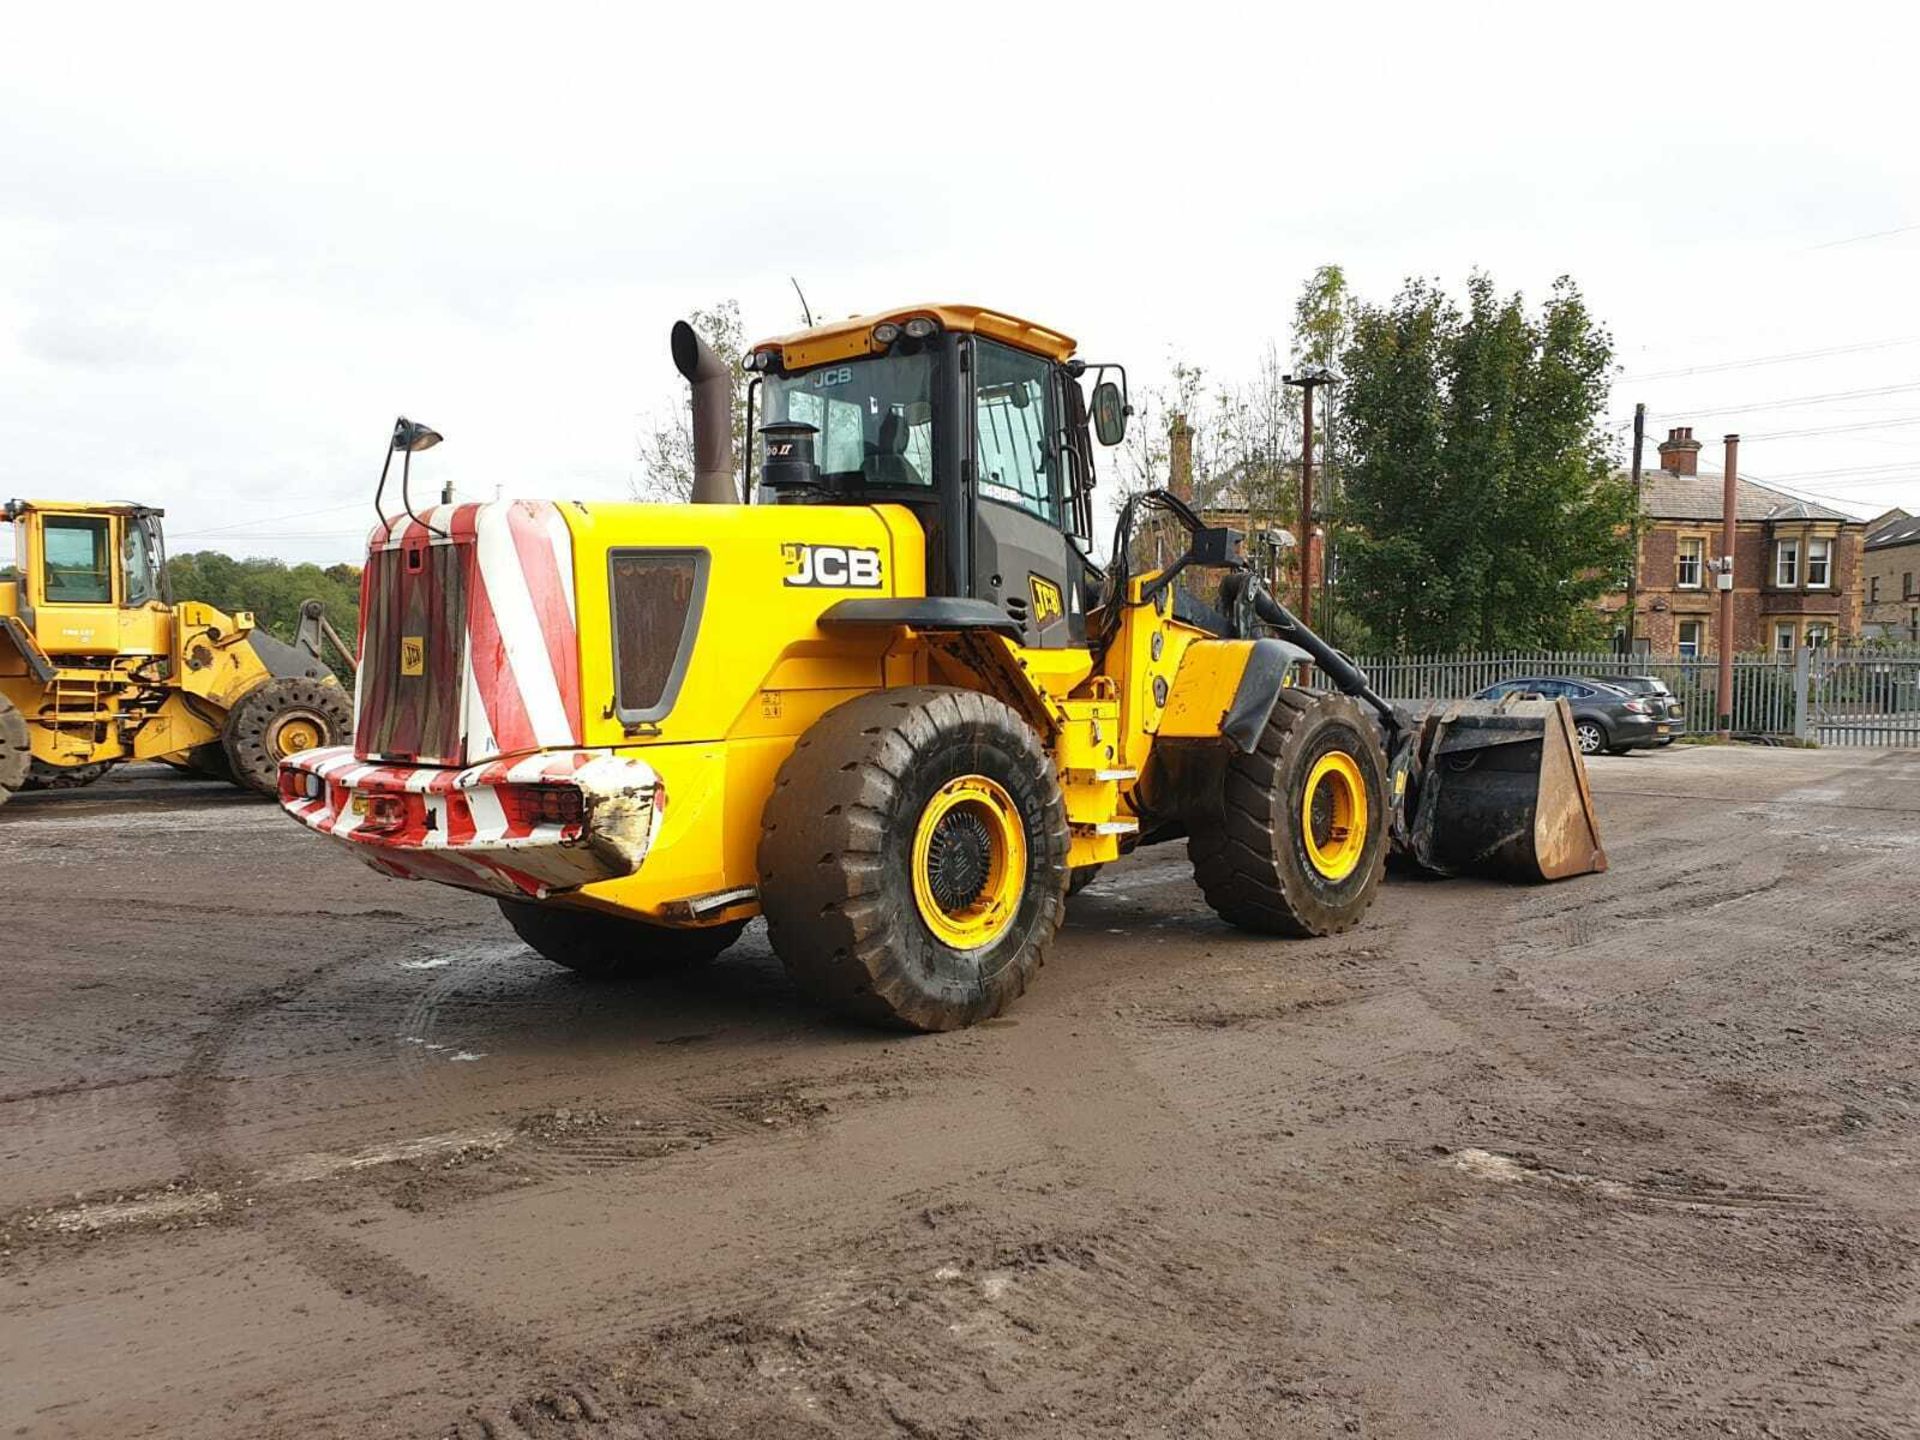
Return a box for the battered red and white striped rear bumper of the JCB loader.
[280,745,666,899]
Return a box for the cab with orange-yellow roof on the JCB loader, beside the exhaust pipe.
[747,305,1123,649]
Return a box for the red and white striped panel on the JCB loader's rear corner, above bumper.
[355,499,586,764]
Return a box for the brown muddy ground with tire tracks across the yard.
[0,749,1920,1440]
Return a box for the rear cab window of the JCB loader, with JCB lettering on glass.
[764,355,933,486]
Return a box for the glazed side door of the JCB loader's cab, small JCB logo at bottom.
[970,336,1087,649]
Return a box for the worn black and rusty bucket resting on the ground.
[1407,697,1607,879]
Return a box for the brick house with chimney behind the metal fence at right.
[1601,426,1866,655]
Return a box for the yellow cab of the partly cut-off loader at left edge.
[0,501,173,657]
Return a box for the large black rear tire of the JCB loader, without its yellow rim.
[760,685,1068,1031]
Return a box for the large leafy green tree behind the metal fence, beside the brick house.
[1340,273,1632,651]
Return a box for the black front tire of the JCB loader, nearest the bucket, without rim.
[1187,687,1388,939]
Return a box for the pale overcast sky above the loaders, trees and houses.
[0,0,1920,561]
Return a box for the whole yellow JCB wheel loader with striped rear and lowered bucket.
[280,305,1605,1029]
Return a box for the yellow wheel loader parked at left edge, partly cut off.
[0,499,353,804]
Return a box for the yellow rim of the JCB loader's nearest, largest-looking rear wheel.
[910,776,1027,950]
